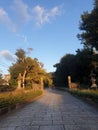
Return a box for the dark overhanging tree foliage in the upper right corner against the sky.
[78,0,98,50]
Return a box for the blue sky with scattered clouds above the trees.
[0,0,94,74]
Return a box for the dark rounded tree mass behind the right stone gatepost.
[53,48,98,86]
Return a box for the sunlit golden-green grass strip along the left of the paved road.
[0,90,42,109]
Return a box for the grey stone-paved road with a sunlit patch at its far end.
[0,89,98,130]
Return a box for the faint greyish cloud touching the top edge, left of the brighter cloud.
[12,0,31,22]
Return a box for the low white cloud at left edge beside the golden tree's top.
[0,50,17,62]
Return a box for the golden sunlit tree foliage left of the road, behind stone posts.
[9,49,52,88]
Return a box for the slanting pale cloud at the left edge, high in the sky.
[0,8,16,32]
